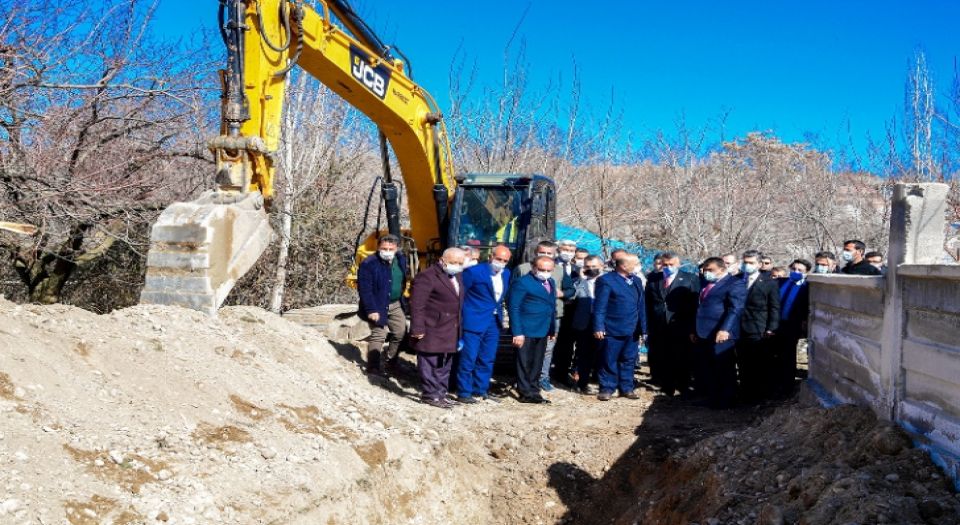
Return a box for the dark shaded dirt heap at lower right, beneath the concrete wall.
[632,405,960,525]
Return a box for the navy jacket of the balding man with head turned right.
[593,272,647,337]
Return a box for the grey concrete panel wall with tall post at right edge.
[808,184,960,488]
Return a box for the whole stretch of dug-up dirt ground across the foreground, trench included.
[0,300,960,525]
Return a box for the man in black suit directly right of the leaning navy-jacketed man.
[736,250,780,402]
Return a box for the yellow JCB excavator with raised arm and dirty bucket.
[140,0,556,315]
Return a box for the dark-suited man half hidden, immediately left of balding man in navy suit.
[571,255,603,395]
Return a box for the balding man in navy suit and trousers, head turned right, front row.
[593,254,647,401]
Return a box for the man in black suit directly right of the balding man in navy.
[644,252,700,396]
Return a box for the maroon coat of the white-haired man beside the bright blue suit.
[410,264,464,354]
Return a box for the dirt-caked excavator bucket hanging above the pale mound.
[140,191,273,316]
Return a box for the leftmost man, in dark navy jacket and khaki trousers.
[357,235,408,375]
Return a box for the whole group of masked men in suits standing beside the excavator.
[357,235,882,409]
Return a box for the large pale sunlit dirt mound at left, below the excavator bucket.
[0,301,489,524]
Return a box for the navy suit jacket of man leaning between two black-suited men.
[696,274,747,353]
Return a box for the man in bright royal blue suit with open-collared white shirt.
[457,244,510,404]
